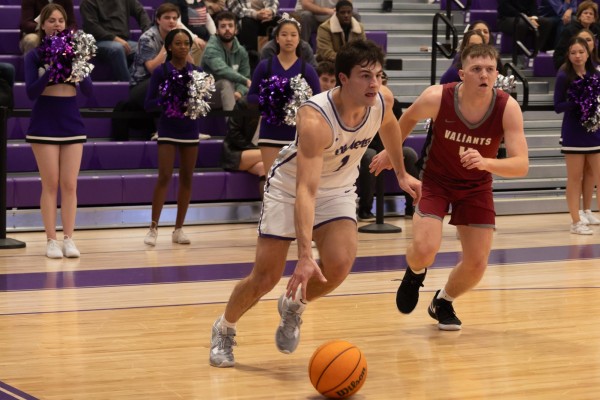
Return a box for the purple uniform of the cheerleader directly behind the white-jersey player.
[248,56,321,147]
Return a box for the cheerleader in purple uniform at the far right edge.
[554,37,600,235]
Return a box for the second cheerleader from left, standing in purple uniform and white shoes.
[144,28,201,246]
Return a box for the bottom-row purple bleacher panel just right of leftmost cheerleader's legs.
[77,175,123,206]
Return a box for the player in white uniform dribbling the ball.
[209,41,421,367]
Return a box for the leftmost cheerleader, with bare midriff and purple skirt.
[25,3,92,258]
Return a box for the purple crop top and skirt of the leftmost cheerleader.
[25,48,92,145]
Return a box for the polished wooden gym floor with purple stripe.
[0,214,600,400]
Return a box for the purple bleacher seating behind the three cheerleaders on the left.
[0,0,424,222]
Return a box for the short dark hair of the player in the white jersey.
[335,39,385,86]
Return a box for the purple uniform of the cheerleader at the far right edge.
[554,70,600,154]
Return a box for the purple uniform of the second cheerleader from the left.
[144,62,202,146]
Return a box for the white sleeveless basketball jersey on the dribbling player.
[266,88,385,197]
